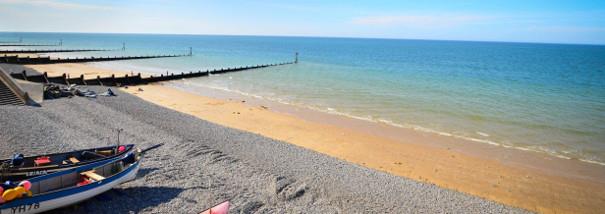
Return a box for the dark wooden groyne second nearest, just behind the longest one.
[0,53,191,65]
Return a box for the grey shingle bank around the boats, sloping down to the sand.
[0,87,527,213]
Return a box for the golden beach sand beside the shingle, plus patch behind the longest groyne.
[23,64,605,213]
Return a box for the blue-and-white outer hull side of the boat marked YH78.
[0,161,139,214]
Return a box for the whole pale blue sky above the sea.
[0,0,605,44]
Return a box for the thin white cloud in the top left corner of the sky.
[0,0,113,10]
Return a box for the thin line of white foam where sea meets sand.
[169,80,605,166]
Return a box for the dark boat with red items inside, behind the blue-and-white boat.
[0,144,134,182]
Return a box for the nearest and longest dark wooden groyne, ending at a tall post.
[11,62,296,86]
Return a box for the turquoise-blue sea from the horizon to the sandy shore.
[0,33,605,163]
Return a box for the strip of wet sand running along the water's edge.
[168,80,605,180]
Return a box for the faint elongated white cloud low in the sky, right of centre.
[352,15,493,27]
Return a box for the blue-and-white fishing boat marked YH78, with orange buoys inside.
[0,148,141,214]
